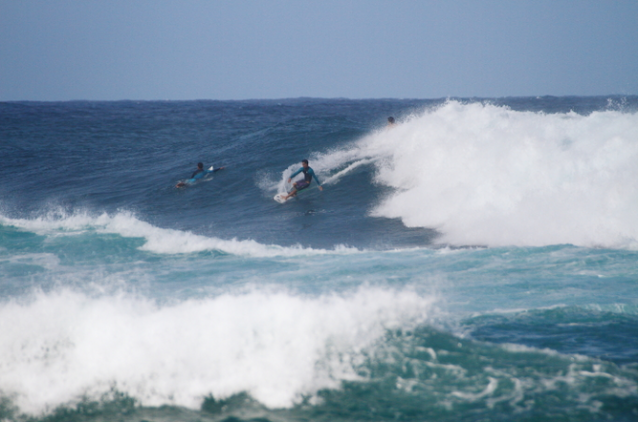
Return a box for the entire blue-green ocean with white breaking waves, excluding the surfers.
[0,96,638,422]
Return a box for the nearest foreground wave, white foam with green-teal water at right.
[0,287,638,420]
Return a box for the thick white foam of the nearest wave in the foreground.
[0,288,433,413]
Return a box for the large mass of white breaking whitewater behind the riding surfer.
[315,101,638,249]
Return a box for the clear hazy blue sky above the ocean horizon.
[0,0,638,101]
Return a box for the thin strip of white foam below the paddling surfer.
[0,212,358,257]
